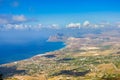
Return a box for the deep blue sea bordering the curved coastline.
[0,38,65,64]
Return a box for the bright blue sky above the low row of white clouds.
[0,0,120,25]
